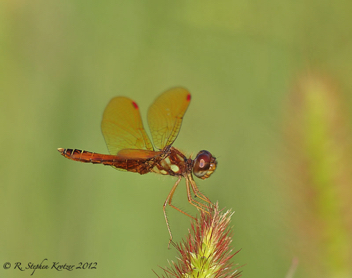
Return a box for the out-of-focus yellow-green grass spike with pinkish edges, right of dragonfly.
[292,74,352,278]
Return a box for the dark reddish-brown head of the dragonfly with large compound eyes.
[193,150,218,180]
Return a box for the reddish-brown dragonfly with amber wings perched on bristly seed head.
[58,87,217,245]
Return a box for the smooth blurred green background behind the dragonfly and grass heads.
[0,0,352,277]
